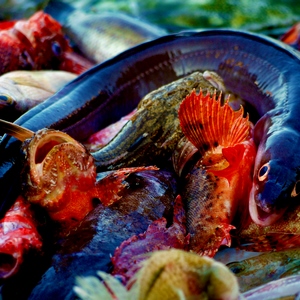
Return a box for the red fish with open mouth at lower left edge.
[0,196,42,278]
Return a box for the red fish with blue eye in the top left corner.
[0,11,94,74]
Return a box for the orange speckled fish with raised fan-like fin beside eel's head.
[179,91,256,257]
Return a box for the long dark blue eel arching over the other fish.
[0,30,300,225]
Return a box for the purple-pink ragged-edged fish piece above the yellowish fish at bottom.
[111,195,190,285]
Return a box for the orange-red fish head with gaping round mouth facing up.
[22,129,96,227]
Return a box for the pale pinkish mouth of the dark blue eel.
[249,188,286,226]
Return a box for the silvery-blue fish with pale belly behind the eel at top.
[45,1,167,63]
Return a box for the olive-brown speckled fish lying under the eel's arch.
[92,72,218,170]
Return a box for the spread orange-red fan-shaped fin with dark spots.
[178,90,251,154]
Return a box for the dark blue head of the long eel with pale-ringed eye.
[249,128,300,226]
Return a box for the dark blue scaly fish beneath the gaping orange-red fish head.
[28,170,178,300]
